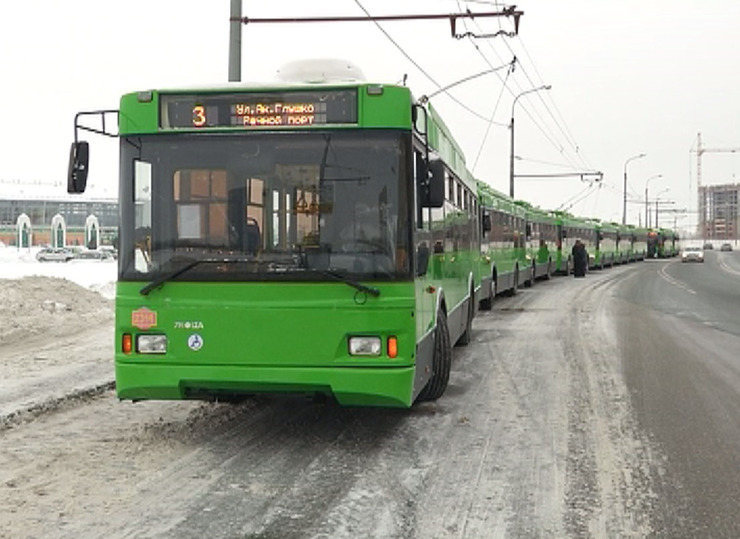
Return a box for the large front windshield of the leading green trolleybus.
[119,130,413,282]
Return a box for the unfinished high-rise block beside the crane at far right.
[698,183,740,240]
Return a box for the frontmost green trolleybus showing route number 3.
[68,63,480,407]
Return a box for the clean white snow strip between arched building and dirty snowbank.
[0,246,117,299]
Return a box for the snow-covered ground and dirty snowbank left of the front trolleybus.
[0,245,117,426]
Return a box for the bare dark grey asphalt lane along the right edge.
[615,251,740,538]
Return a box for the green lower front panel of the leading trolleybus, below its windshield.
[116,282,416,406]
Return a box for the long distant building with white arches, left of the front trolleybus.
[0,196,118,247]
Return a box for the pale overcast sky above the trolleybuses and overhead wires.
[0,0,740,234]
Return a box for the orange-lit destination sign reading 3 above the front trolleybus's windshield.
[159,90,357,129]
